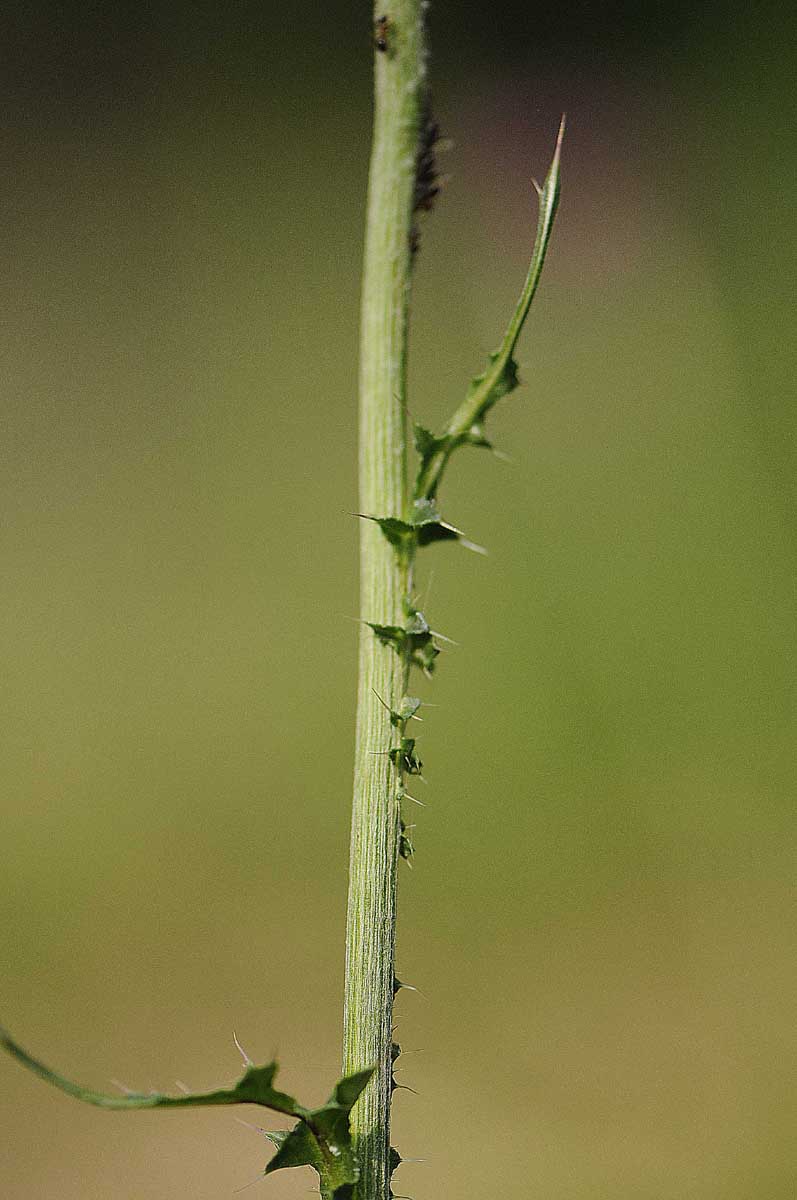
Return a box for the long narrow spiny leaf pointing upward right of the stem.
[415,118,564,499]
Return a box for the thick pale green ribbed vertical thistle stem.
[343,0,426,1200]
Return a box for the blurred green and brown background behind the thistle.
[0,0,797,1200]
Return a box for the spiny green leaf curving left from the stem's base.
[0,1028,373,1198]
